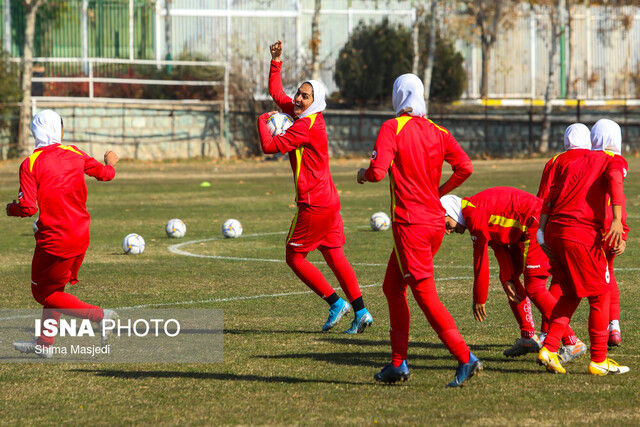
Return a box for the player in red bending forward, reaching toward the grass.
[441,187,587,361]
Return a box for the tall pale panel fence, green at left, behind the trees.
[0,0,640,99]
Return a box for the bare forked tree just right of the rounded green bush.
[463,0,517,98]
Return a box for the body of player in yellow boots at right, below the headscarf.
[537,140,629,375]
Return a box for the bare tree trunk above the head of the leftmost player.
[17,0,48,157]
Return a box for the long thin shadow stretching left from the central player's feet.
[70,369,369,385]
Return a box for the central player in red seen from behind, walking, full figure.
[357,74,482,387]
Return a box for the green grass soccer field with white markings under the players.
[0,158,640,425]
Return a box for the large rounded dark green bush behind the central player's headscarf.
[334,20,466,106]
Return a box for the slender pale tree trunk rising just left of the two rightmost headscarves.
[538,0,566,154]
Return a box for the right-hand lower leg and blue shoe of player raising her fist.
[320,246,373,334]
